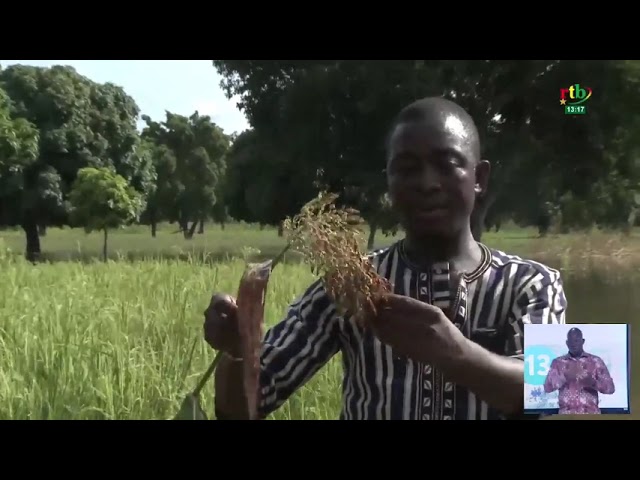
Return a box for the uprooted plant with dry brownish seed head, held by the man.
[175,193,391,420]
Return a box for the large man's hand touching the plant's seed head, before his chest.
[368,294,466,365]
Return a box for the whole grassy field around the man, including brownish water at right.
[0,225,640,419]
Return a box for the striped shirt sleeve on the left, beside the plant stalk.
[259,281,340,418]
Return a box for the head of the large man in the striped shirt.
[387,97,490,237]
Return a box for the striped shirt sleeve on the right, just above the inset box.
[505,265,567,360]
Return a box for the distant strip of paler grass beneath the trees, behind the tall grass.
[0,224,640,271]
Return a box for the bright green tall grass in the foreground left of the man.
[0,249,340,419]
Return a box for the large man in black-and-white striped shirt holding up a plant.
[204,98,566,420]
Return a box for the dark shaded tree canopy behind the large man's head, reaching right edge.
[214,60,640,241]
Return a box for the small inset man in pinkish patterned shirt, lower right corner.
[544,328,616,414]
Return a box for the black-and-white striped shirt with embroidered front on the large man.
[260,241,567,420]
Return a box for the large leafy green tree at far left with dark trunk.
[0,65,155,259]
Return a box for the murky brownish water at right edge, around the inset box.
[554,270,640,420]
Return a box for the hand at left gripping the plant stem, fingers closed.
[204,293,241,358]
